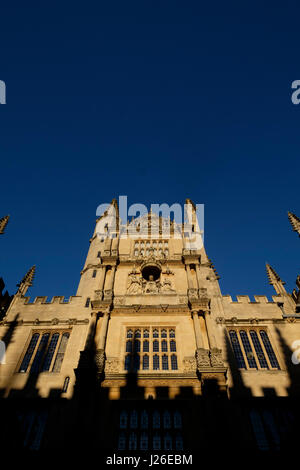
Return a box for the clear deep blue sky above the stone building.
[0,0,300,302]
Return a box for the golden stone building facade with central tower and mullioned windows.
[0,204,300,450]
